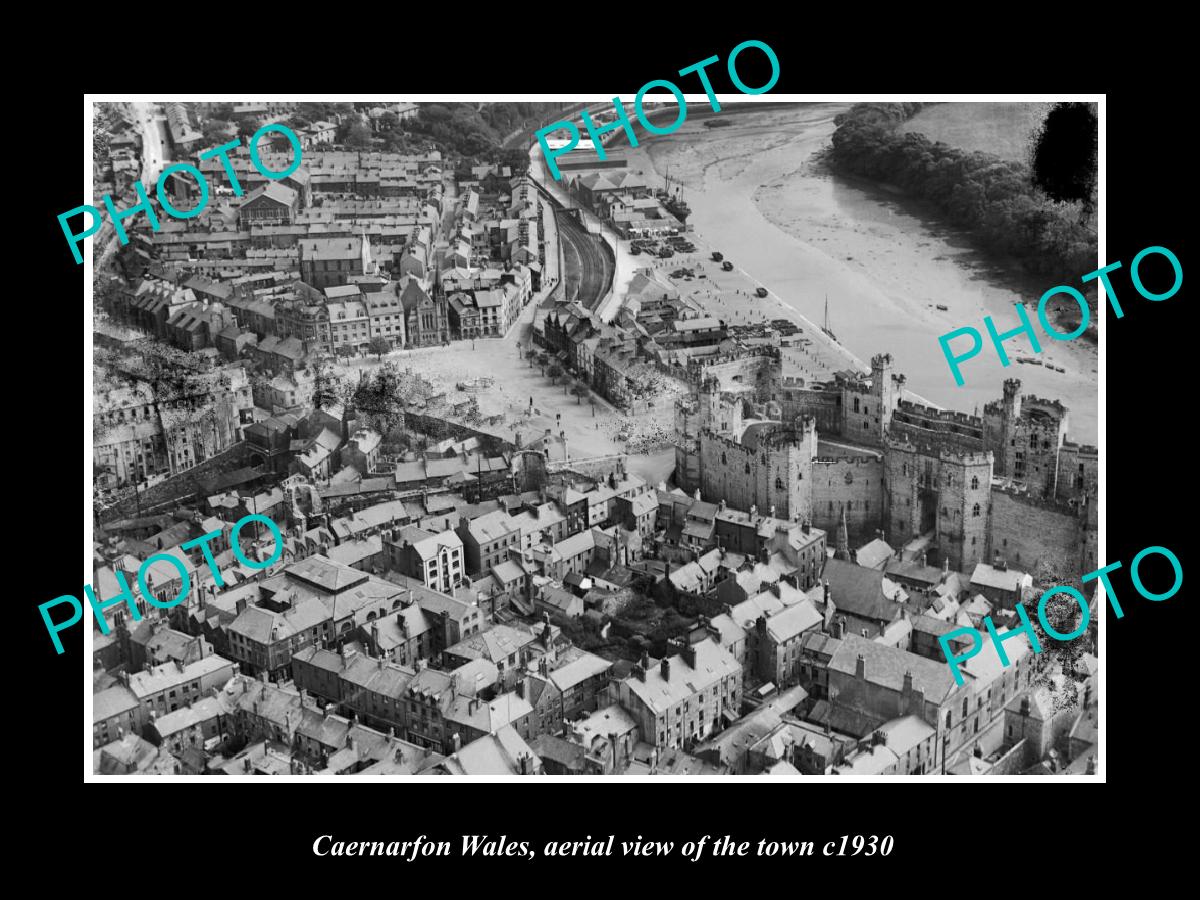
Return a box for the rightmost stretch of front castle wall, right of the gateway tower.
[989,488,1096,580]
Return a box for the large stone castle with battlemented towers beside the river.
[676,354,1098,577]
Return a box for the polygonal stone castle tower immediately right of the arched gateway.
[937,450,994,572]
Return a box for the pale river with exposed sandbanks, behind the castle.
[624,103,1098,444]
